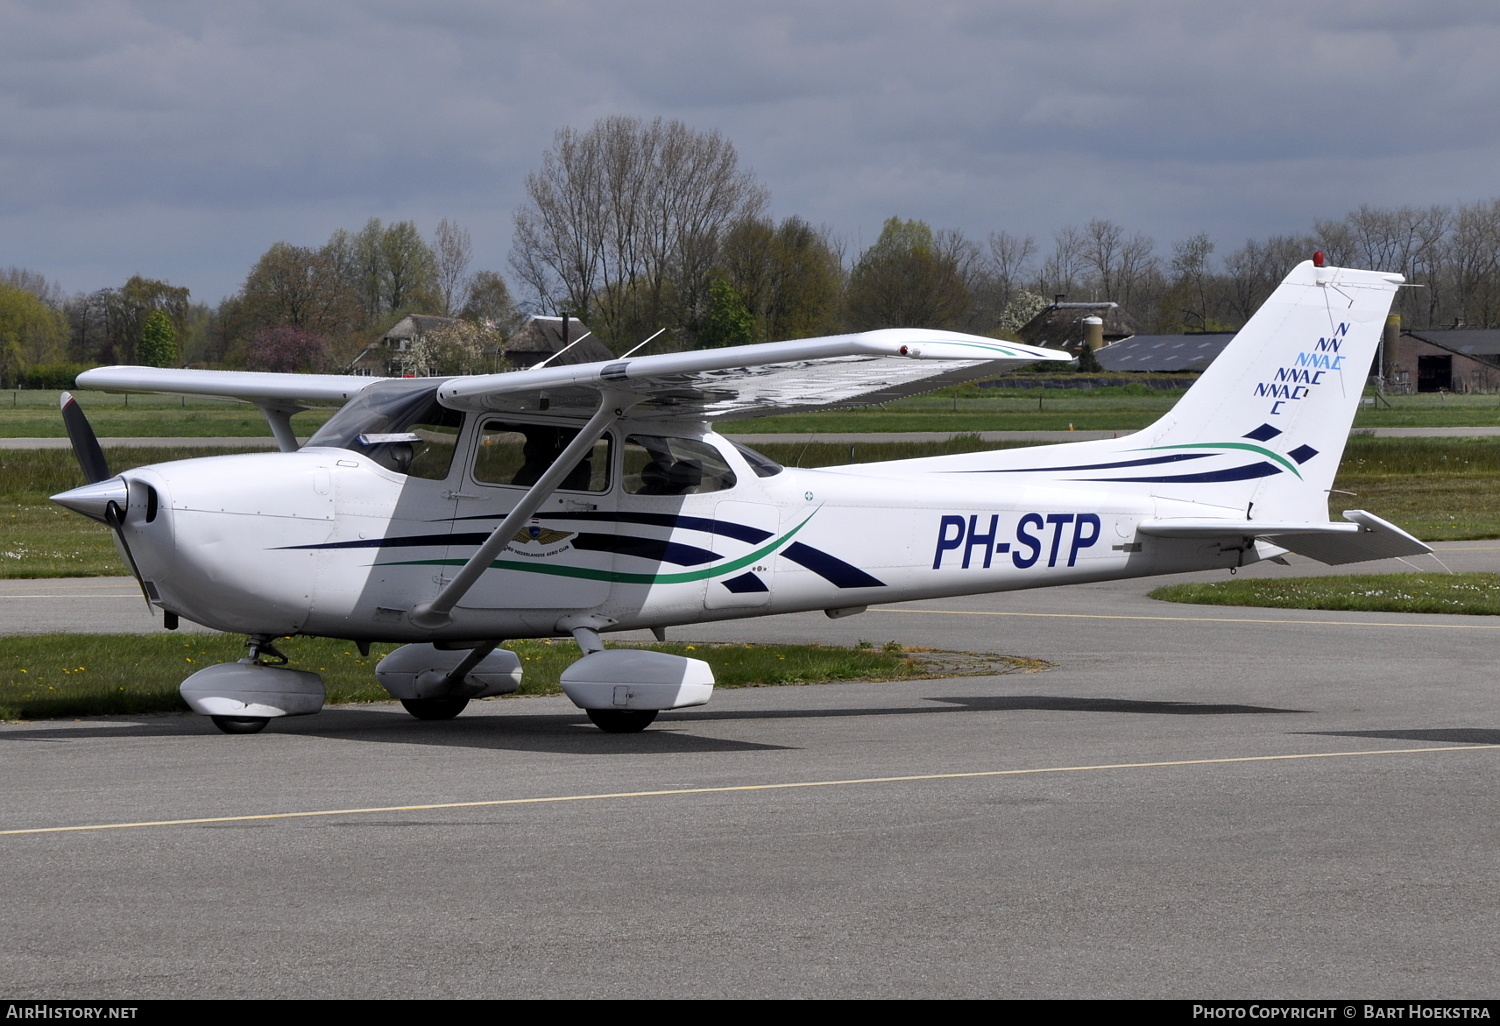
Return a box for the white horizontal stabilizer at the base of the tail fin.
[1137,510,1433,566]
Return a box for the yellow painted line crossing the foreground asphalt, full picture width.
[0,744,1500,837]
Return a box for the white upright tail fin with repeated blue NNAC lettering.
[1116,261,1404,522]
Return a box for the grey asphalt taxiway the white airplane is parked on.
[0,542,1500,999]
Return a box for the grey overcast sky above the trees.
[0,0,1500,303]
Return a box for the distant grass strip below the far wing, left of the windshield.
[0,390,333,441]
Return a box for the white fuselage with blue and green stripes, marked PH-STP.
[114,416,1266,642]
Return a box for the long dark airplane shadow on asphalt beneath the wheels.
[0,695,1304,755]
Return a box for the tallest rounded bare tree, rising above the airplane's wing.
[510,116,765,342]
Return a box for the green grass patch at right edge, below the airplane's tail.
[1151,573,1500,617]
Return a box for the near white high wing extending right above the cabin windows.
[438,329,1071,420]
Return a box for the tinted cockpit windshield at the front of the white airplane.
[308,380,464,480]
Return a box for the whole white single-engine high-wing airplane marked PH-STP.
[53,261,1430,734]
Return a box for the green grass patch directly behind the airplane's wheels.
[0,635,1046,720]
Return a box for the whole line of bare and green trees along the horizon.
[0,117,1500,387]
